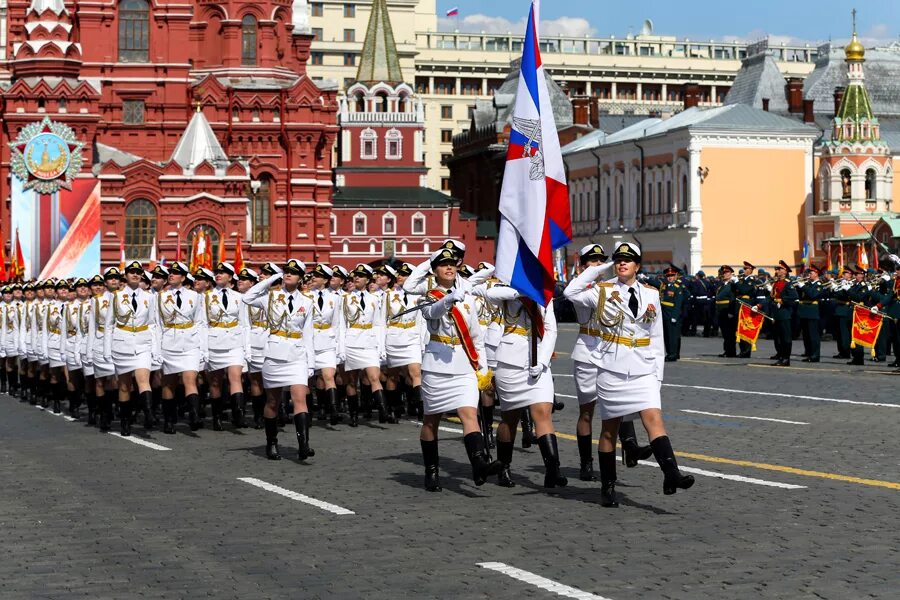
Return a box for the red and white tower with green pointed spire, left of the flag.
[330,0,496,267]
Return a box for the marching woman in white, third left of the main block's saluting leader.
[103,261,160,436]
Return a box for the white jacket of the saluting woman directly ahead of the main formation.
[242,277,316,374]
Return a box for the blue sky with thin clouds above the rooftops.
[437,0,900,44]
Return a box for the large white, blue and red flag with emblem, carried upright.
[496,0,572,306]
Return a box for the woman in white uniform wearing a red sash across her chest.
[404,248,502,492]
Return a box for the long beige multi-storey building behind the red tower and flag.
[309,0,819,191]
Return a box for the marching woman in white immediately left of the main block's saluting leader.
[203,262,250,431]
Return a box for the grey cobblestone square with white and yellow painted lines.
[0,325,900,600]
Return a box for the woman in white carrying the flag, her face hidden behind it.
[487,285,568,488]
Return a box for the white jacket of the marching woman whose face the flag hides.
[487,285,556,370]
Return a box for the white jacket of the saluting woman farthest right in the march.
[565,265,666,382]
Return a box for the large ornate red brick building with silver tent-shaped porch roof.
[0,0,338,265]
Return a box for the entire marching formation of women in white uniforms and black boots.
[0,240,693,506]
